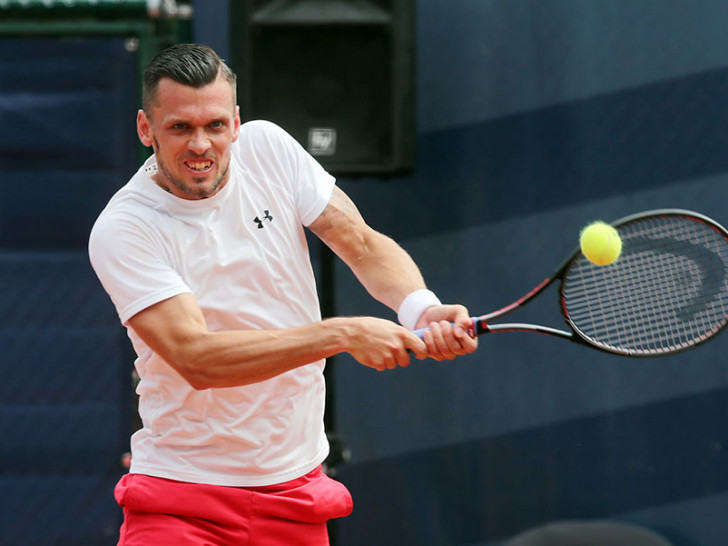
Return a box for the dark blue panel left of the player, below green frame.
[0,36,138,546]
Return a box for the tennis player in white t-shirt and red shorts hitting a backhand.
[89,44,477,546]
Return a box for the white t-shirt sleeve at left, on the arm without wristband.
[89,212,191,324]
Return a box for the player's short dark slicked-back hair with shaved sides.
[142,44,237,113]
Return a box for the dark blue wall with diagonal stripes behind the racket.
[324,0,728,546]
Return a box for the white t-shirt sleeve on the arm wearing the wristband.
[237,120,336,226]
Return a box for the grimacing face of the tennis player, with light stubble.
[137,76,245,199]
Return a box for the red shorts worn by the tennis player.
[114,467,353,546]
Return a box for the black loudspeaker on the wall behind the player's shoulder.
[230,0,415,175]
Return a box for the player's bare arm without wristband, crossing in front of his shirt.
[128,293,426,389]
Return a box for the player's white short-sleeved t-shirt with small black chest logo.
[89,121,334,486]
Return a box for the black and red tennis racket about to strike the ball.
[417,209,728,357]
